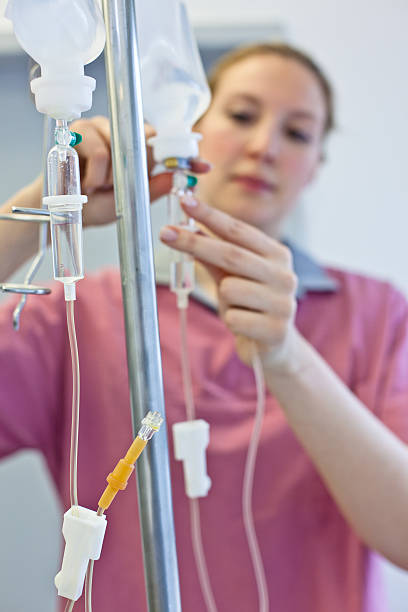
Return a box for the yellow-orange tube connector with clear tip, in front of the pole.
[98,412,163,511]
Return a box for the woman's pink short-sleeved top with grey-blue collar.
[0,246,408,612]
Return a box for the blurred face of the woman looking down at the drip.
[197,55,327,236]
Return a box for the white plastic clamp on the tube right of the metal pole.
[173,419,211,499]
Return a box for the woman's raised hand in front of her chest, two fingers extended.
[160,198,297,370]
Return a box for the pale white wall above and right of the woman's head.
[187,0,408,292]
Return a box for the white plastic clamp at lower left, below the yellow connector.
[55,506,106,601]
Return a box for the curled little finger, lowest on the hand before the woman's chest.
[223,308,292,345]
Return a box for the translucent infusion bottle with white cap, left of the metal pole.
[6,0,105,121]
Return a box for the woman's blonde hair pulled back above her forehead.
[208,43,335,135]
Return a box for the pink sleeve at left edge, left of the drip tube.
[0,291,66,486]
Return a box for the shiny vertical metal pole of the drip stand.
[103,0,181,612]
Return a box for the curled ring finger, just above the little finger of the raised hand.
[218,274,296,319]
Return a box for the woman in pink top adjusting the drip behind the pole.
[0,44,408,612]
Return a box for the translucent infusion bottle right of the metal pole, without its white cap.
[136,0,210,136]
